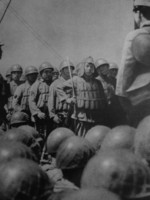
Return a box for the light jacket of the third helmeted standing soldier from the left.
[29,79,49,116]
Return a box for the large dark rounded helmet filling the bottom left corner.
[0,159,53,200]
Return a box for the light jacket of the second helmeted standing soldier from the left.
[13,81,31,113]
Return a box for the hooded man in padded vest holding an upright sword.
[57,57,106,137]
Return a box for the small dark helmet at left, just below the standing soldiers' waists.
[10,111,30,126]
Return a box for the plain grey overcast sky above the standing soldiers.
[0,0,133,74]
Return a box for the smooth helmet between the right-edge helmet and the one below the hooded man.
[101,125,135,150]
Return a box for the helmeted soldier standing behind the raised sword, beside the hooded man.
[48,60,74,128]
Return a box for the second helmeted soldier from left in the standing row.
[13,66,38,116]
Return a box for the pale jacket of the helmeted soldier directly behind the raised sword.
[48,76,70,118]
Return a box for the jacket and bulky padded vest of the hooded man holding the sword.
[57,76,106,123]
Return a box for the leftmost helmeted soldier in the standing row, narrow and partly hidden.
[7,64,23,122]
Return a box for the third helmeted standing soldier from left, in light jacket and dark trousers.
[29,62,54,138]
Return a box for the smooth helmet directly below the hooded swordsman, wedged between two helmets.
[85,125,110,150]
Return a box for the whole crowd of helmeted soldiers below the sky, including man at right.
[0,0,150,200]
